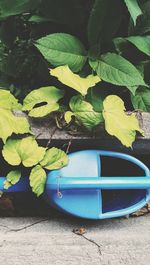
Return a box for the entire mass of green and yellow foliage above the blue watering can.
[0,0,150,196]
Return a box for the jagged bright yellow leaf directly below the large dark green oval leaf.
[50,65,101,96]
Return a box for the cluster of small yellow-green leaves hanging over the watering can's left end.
[2,136,68,196]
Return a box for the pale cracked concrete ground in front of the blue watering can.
[0,210,150,265]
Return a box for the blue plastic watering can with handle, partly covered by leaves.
[0,150,150,219]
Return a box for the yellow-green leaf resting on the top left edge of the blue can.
[40,147,68,170]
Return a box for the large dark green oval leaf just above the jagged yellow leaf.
[35,33,87,72]
